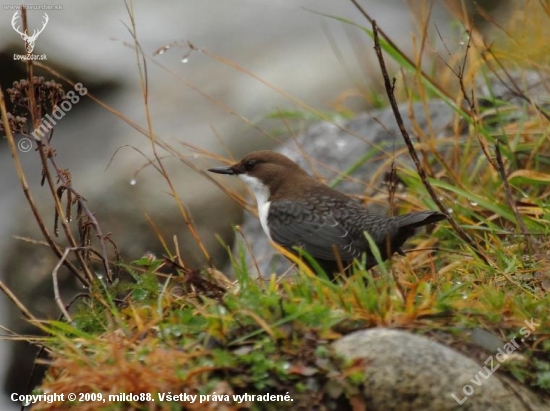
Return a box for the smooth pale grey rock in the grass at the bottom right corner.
[333,328,550,411]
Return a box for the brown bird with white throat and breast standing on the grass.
[208,150,447,279]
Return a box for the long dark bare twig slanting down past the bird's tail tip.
[372,20,490,265]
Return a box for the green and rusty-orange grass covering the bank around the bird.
[2,2,550,410]
